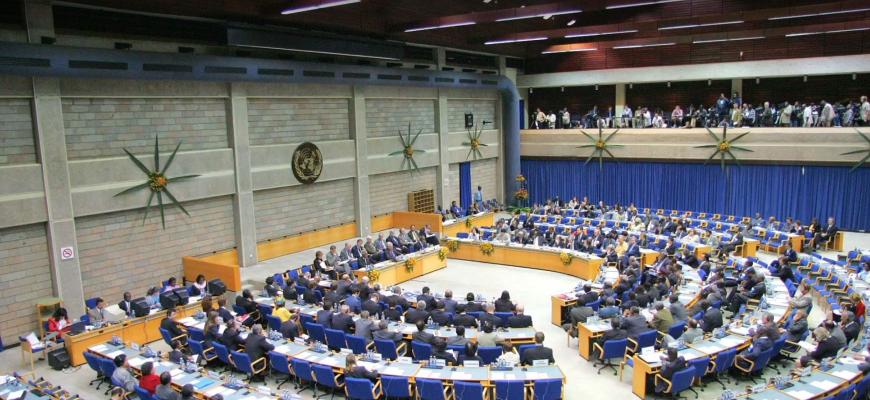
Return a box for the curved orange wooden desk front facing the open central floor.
[447,241,604,280]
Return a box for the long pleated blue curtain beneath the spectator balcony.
[522,159,870,230]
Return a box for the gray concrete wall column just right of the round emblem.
[350,86,372,237]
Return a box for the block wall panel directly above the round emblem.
[248,98,350,146]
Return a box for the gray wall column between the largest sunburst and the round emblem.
[227,83,257,267]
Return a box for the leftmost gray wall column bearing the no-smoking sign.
[33,77,85,316]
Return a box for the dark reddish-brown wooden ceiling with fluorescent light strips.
[23,0,870,69]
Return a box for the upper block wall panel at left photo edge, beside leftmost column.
[0,99,36,165]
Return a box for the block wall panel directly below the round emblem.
[254,179,355,241]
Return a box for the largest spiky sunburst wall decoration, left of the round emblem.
[113,137,199,229]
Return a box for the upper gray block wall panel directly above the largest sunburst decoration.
[62,98,228,159]
